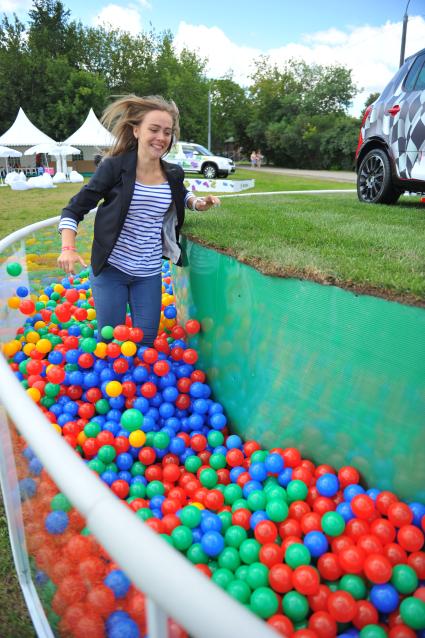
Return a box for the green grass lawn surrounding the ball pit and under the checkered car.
[0,168,425,638]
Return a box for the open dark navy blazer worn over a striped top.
[61,150,188,275]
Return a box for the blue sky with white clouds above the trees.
[0,0,425,116]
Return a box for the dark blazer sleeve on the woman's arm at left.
[61,157,116,224]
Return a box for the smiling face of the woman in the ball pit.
[133,110,173,160]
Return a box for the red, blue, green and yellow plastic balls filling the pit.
[3,264,425,638]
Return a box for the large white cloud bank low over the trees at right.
[175,16,425,116]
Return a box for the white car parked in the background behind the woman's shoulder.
[164,142,235,179]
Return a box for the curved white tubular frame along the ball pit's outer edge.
[0,217,276,638]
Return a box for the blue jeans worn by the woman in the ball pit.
[90,264,162,346]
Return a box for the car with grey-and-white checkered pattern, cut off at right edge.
[356,49,425,204]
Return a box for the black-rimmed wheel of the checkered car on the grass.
[357,148,401,204]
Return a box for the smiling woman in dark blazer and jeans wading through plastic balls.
[58,95,220,345]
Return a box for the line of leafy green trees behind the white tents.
[0,0,372,169]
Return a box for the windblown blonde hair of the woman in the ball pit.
[101,95,180,156]
